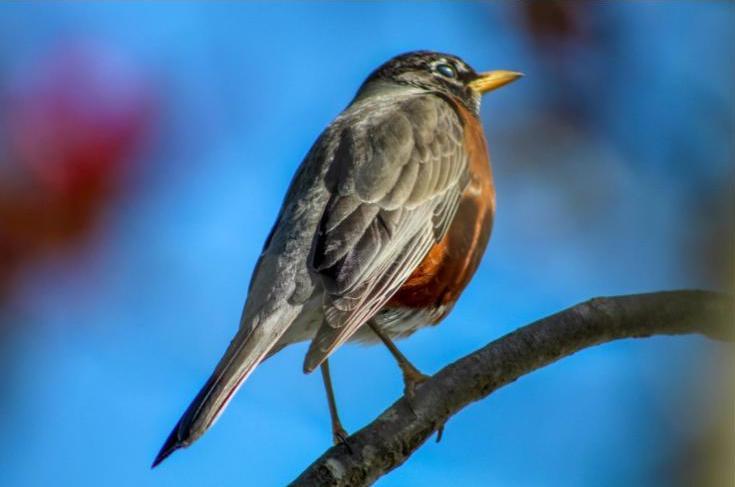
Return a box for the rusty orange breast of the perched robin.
[387,107,495,316]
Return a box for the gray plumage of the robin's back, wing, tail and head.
[154,53,479,466]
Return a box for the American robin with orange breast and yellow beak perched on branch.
[153,51,520,467]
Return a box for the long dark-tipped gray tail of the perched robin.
[151,305,298,468]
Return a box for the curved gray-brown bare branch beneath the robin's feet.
[291,291,735,486]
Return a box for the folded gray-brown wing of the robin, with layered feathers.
[304,95,469,371]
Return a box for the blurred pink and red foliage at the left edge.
[0,44,155,301]
